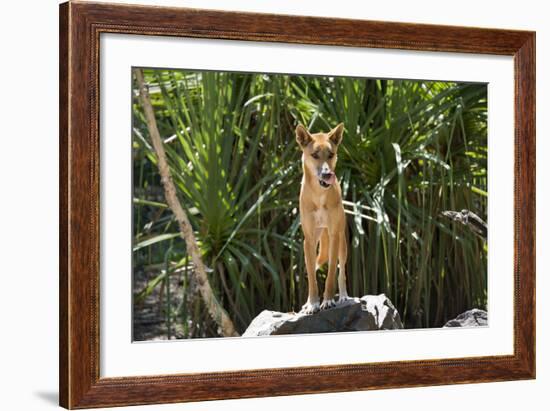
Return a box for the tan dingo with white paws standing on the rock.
[296,124,348,314]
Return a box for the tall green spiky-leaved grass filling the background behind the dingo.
[133,69,487,338]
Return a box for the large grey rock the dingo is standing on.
[242,294,403,337]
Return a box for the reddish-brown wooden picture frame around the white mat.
[59,2,535,409]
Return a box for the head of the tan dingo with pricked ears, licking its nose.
[296,123,344,188]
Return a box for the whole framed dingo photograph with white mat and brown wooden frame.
[59,2,535,408]
